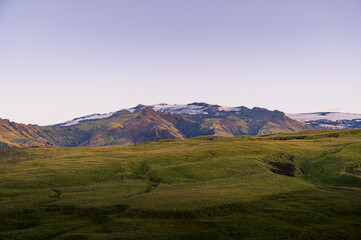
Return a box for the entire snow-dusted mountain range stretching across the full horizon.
[0,102,361,147]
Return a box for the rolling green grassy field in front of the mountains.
[0,130,361,239]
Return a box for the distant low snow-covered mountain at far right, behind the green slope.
[287,112,361,129]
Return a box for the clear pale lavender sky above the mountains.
[0,0,361,125]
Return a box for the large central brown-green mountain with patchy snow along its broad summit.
[0,103,316,147]
